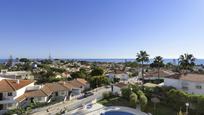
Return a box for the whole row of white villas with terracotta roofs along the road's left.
[0,79,90,115]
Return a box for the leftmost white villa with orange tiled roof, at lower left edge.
[0,79,34,114]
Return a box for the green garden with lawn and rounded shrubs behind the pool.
[99,85,204,115]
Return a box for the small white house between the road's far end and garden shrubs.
[112,82,128,95]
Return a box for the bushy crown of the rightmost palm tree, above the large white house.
[179,54,195,71]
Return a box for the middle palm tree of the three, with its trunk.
[150,56,164,79]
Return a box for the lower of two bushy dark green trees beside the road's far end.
[90,76,110,88]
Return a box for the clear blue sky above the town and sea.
[0,0,204,58]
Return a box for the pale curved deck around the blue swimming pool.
[66,103,147,115]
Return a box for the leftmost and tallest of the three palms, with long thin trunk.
[136,51,149,83]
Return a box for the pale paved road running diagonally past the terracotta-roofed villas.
[31,87,111,115]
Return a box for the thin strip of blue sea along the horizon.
[0,59,204,65]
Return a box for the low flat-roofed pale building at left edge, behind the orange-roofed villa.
[0,70,34,80]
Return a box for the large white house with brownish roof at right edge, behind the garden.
[164,73,204,94]
